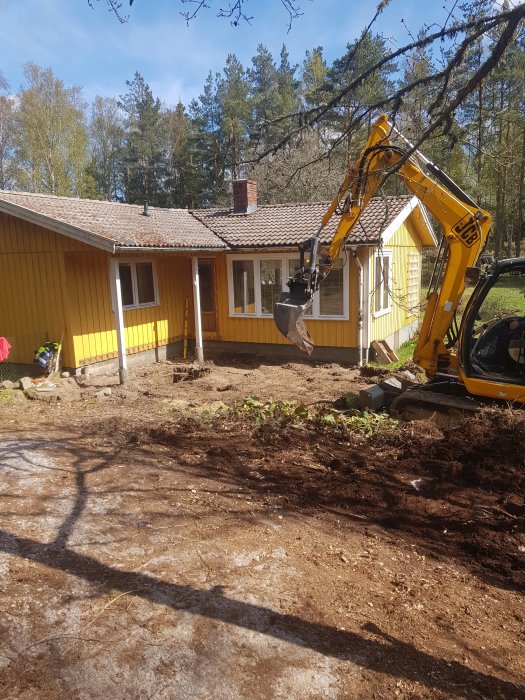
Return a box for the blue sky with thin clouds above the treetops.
[0,0,460,106]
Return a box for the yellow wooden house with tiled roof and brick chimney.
[0,180,436,379]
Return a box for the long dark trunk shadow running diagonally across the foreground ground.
[0,530,525,698]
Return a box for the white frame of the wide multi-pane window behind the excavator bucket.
[227,252,350,321]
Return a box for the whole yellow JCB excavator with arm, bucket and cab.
[274,114,525,412]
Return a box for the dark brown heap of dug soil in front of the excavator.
[129,411,525,588]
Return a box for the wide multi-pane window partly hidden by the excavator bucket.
[228,253,348,319]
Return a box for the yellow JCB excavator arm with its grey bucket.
[274,114,492,376]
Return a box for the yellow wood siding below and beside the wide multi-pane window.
[211,253,366,348]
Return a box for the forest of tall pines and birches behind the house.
[0,0,525,256]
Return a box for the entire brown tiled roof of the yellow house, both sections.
[0,190,410,250]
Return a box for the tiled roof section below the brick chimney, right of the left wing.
[192,195,411,248]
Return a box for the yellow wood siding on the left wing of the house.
[0,214,193,367]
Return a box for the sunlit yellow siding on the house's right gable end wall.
[369,219,421,341]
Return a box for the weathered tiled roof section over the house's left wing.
[0,190,224,249]
